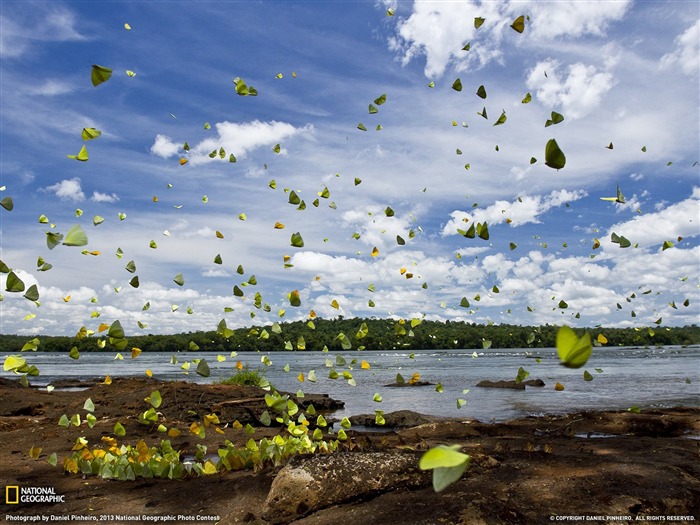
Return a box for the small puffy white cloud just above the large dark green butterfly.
[527,59,615,119]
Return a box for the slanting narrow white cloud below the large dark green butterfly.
[442,190,588,236]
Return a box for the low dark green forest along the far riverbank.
[0,317,700,353]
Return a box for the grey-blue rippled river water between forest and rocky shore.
[6,347,700,422]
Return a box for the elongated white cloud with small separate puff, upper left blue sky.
[151,120,314,165]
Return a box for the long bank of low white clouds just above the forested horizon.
[0,234,700,333]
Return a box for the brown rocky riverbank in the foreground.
[0,378,700,525]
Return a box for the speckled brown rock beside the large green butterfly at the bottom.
[262,451,431,524]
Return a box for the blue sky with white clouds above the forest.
[0,0,700,336]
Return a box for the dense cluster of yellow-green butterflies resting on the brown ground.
[61,390,340,481]
